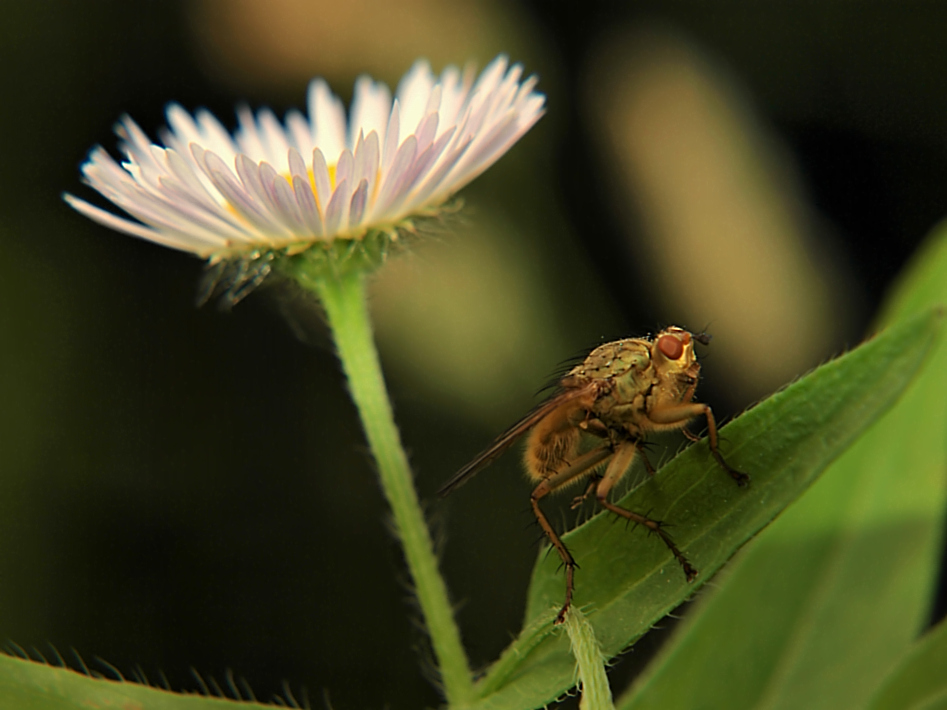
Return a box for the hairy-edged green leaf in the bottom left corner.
[0,654,273,710]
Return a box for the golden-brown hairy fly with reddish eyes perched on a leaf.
[438,326,750,624]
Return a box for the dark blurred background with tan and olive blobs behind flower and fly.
[0,0,947,708]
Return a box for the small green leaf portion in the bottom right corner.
[868,621,947,710]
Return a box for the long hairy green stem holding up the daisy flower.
[310,271,474,708]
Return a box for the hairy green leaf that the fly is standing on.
[475,313,941,708]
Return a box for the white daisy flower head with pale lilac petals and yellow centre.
[64,56,545,262]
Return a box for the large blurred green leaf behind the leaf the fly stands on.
[618,225,947,710]
